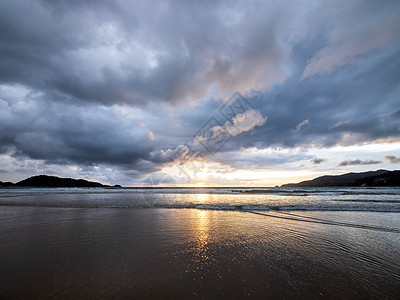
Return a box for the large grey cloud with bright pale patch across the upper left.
[0,1,300,105]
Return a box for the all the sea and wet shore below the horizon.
[0,188,400,299]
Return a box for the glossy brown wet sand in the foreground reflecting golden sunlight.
[0,206,400,299]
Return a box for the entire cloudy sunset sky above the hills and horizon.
[0,0,400,186]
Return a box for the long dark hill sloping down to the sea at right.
[282,170,400,187]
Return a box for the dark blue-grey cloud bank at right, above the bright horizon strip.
[223,40,400,148]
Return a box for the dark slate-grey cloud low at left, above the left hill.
[0,87,155,165]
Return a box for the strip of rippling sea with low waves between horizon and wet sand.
[0,188,400,212]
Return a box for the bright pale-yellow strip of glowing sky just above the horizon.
[151,142,400,187]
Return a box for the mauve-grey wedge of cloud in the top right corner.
[302,1,400,79]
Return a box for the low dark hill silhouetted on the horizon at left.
[14,175,109,187]
